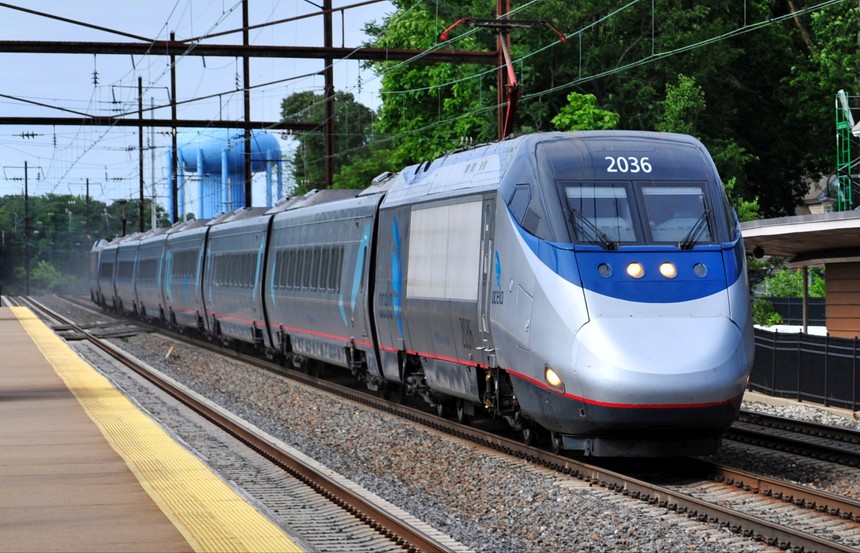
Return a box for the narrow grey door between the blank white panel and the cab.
[476,196,504,366]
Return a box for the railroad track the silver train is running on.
[40,296,860,552]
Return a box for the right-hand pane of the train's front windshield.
[641,184,712,243]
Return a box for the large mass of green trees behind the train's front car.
[352,0,848,217]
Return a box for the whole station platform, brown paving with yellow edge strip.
[0,307,302,552]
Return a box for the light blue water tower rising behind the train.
[167,129,283,221]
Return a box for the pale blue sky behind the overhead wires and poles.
[0,0,393,212]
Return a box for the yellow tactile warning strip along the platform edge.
[10,307,303,552]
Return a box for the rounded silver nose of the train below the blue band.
[574,317,752,406]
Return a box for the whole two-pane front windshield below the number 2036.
[563,182,714,249]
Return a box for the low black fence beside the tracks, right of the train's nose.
[749,329,860,411]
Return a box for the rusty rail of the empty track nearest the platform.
[16,297,466,552]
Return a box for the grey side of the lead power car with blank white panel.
[374,185,496,403]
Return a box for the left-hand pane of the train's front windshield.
[565,182,636,247]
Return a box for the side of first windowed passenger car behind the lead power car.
[265,195,381,385]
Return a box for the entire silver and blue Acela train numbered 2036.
[90,131,754,457]
